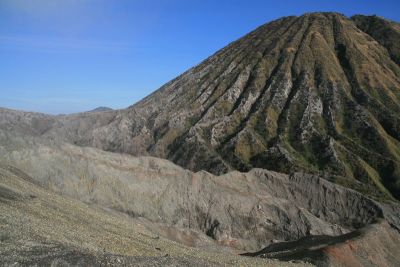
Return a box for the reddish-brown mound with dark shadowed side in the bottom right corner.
[245,222,400,267]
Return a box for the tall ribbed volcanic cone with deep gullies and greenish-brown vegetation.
[3,13,400,200]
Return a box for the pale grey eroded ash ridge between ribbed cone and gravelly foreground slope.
[0,138,384,252]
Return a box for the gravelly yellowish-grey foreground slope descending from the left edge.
[0,166,296,266]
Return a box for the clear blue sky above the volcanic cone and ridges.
[0,0,400,114]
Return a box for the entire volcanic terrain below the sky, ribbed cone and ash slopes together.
[0,13,400,266]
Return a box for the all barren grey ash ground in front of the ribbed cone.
[0,139,400,266]
